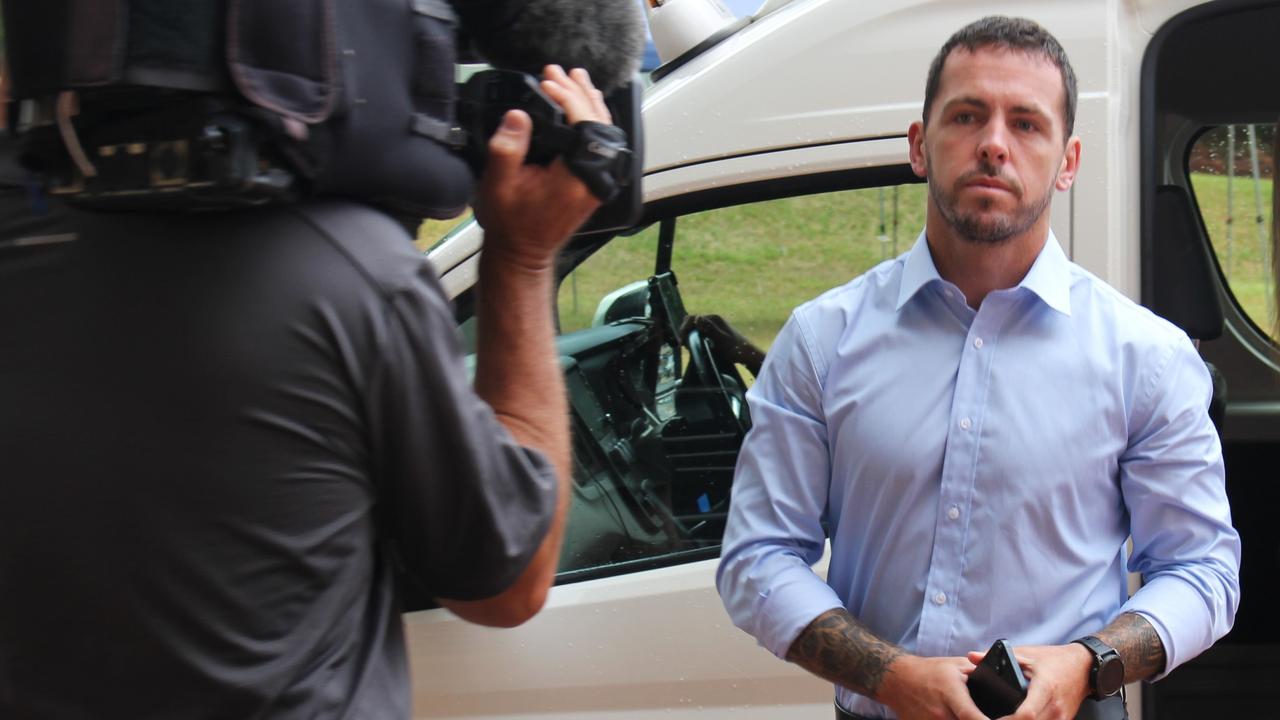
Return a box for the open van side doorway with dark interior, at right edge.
[1140,3,1280,720]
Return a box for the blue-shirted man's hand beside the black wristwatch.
[969,643,1093,720]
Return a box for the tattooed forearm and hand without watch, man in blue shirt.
[787,609,984,720]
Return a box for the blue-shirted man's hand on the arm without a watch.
[876,655,987,720]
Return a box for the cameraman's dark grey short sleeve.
[370,265,556,600]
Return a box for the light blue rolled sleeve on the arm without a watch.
[716,310,844,659]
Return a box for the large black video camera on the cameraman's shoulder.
[4,0,643,231]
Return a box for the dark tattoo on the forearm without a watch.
[787,609,902,697]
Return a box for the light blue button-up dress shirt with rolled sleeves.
[717,233,1240,716]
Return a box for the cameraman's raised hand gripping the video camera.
[476,65,611,270]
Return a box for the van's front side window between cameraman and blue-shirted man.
[557,184,927,582]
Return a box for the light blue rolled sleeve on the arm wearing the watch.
[1120,337,1240,679]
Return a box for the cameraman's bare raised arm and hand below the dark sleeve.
[442,65,609,625]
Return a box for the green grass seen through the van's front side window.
[559,184,925,347]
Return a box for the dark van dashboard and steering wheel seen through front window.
[559,220,751,582]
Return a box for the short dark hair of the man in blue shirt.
[923,15,1076,142]
